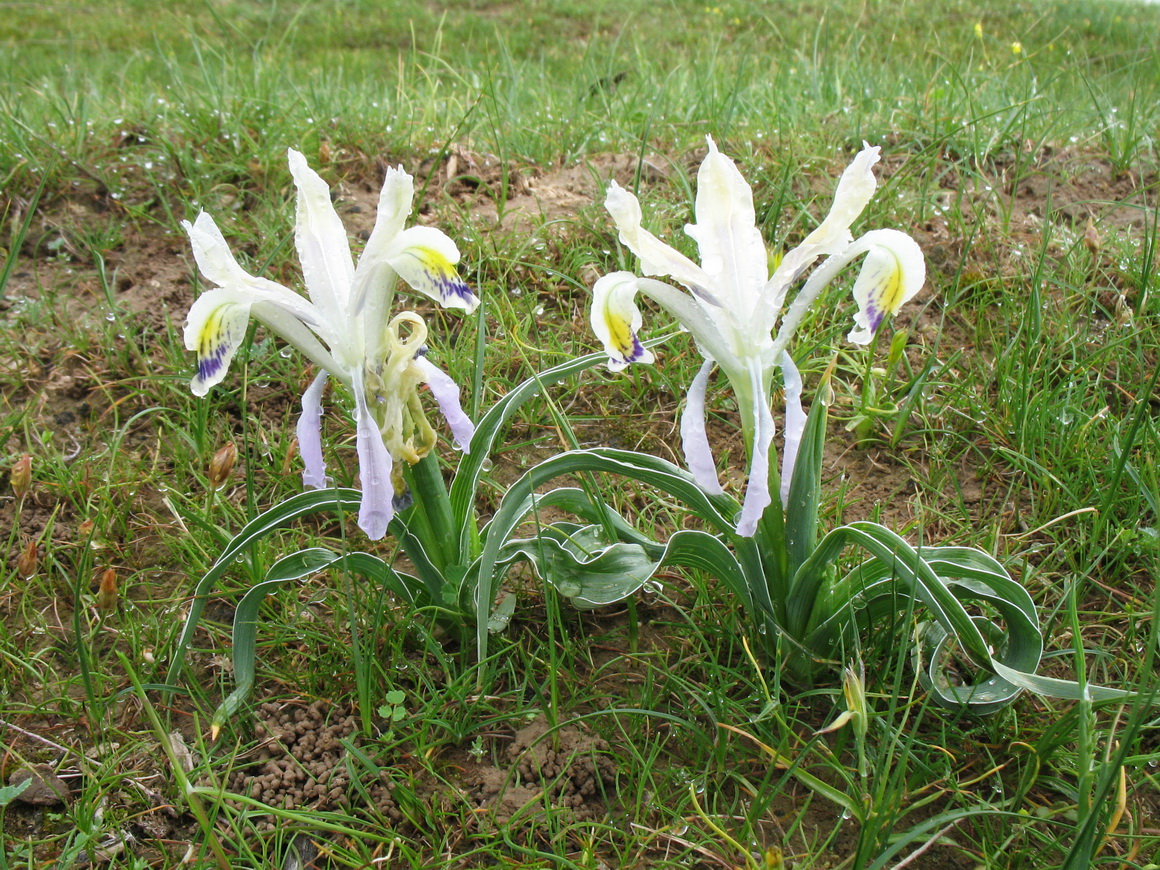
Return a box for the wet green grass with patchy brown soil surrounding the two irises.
[0,0,1160,870]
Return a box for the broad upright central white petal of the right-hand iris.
[684,139,769,317]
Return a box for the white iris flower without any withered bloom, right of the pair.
[592,139,926,535]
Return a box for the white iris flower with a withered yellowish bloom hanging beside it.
[183,148,479,539]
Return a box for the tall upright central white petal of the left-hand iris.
[289,148,355,320]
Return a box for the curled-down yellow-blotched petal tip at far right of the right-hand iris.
[848,230,927,345]
